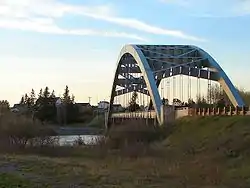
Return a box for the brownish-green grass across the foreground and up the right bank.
[0,116,250,188]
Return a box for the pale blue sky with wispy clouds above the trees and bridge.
[0,0,250,104]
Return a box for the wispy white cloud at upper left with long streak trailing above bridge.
[0,0,205,41]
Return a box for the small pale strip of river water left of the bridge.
[54,135,102,146]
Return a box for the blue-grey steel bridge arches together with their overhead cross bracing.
[108,45,245,127]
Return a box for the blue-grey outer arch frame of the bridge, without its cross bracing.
[108,45,245,127]
